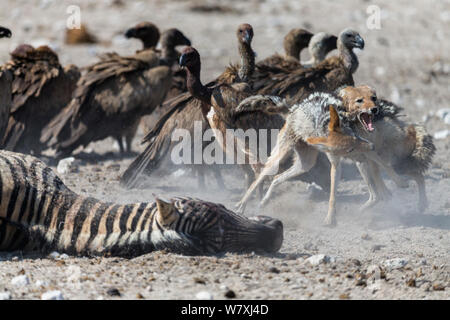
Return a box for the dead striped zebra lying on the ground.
[0,151,283,256]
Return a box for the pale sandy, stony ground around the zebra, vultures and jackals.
[0,0,450,299]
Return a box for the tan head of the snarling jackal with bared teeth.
[338,86,379,132]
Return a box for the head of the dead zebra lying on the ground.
[152,198,283,254]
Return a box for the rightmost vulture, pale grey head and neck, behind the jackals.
[254,29,364,103]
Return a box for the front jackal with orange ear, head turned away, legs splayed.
[237,92,377,224]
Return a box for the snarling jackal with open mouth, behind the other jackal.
[338,86,436,211]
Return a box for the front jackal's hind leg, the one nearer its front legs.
[260,146,319,206]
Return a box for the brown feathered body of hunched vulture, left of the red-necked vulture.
[42,50,172,157]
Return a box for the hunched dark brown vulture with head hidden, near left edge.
[3,44,80,154]
